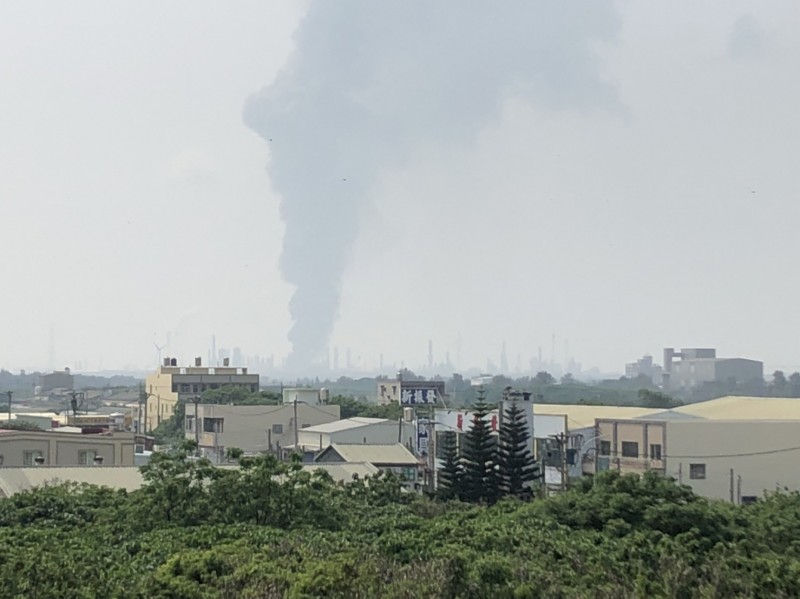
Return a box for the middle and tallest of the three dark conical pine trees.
[462,388,498,503]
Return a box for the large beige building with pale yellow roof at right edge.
[594,397,800,504]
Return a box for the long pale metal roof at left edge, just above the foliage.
[0,466,143,497]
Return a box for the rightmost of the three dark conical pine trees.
[498,401,541,497]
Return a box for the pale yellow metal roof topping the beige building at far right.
[672,395,800,420]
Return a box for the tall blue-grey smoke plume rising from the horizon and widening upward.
[244,0,619,369]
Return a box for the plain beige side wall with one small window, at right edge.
[666,420,800,502]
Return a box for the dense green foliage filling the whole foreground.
[0,447,800,599]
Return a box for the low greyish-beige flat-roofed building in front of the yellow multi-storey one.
[184,403,340,463]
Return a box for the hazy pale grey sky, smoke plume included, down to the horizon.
[0,0,800,372]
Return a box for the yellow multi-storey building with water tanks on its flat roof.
[142,358,259,433]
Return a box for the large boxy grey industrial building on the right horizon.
[663,347,764,390]
